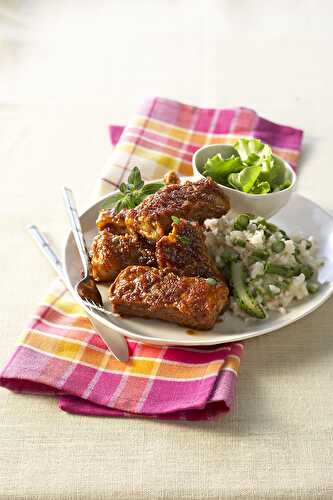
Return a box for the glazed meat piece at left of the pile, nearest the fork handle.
[90,229,156,281]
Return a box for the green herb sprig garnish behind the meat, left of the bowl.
[102,167,164,212]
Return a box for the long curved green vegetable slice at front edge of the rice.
[231,262,266,319]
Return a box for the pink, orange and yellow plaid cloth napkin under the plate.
[0,98,302,420]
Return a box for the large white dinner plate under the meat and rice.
[64,194,333,346]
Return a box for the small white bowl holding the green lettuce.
[192,144,296,218]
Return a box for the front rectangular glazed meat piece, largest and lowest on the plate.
[109,266,229,330]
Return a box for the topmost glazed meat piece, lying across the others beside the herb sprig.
[126,178,229,241]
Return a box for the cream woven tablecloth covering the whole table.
[0,0,333,500]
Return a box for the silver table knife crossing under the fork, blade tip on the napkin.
[28,224,129,363]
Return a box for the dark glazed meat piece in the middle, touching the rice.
[156,219,223,280]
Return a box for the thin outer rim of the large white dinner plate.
[62,190,333,347]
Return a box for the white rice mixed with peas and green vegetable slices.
[206,214,322,319]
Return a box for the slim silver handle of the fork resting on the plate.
[63,187,90,276]
